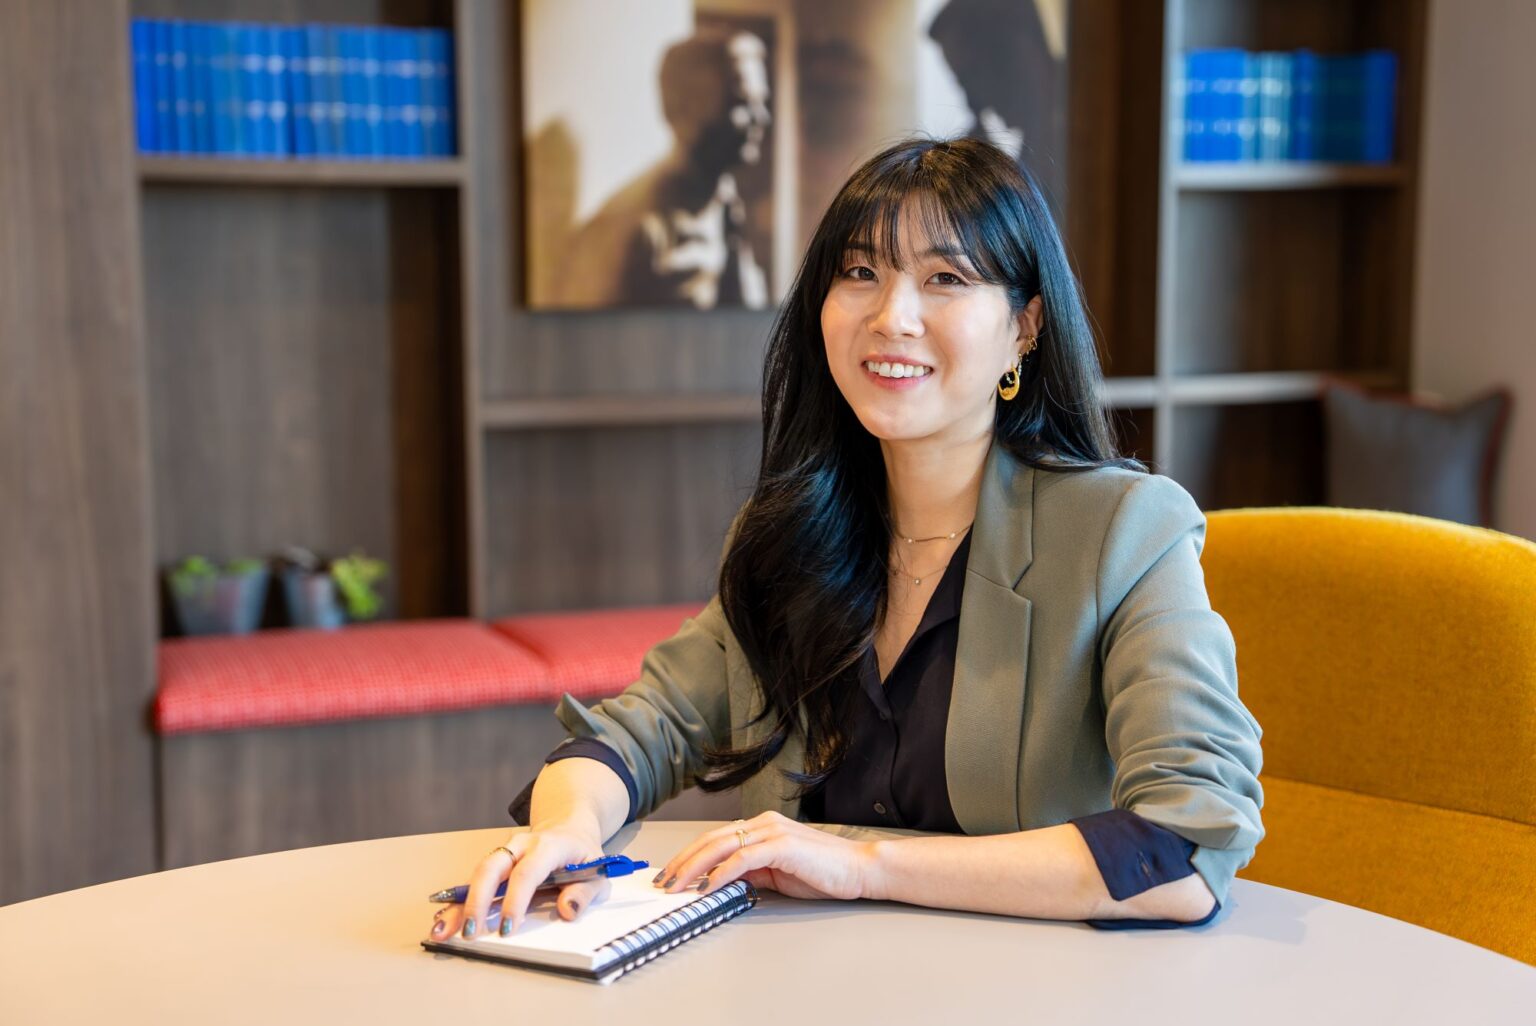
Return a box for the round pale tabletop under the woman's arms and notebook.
[0,822,1536,1026]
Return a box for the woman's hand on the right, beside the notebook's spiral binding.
[657,813,876,899]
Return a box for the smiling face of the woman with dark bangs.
[822,204,1041,442]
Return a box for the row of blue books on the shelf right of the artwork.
[1181,49,1398,163]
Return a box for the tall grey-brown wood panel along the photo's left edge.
[0,0,155,903]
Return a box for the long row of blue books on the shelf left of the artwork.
[132,18,455,160]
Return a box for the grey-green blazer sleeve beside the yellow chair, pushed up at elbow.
[1097,475,1264,905]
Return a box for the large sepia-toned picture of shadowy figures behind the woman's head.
[522,0,1068,310]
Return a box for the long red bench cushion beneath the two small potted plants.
[155,619,559,734]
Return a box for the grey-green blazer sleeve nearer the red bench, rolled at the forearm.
[554,596,730,819]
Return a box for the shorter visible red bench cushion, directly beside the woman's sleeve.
[492,602,703,699]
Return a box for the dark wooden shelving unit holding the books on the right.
[1148,0,1425,508]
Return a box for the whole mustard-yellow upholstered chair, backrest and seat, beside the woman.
[1201,508,1536,965]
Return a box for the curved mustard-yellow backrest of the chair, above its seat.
[1201,507,1536,825]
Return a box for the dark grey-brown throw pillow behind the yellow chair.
[1322,379,1511,527]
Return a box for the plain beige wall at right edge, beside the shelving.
[1413,0,1536,539]
